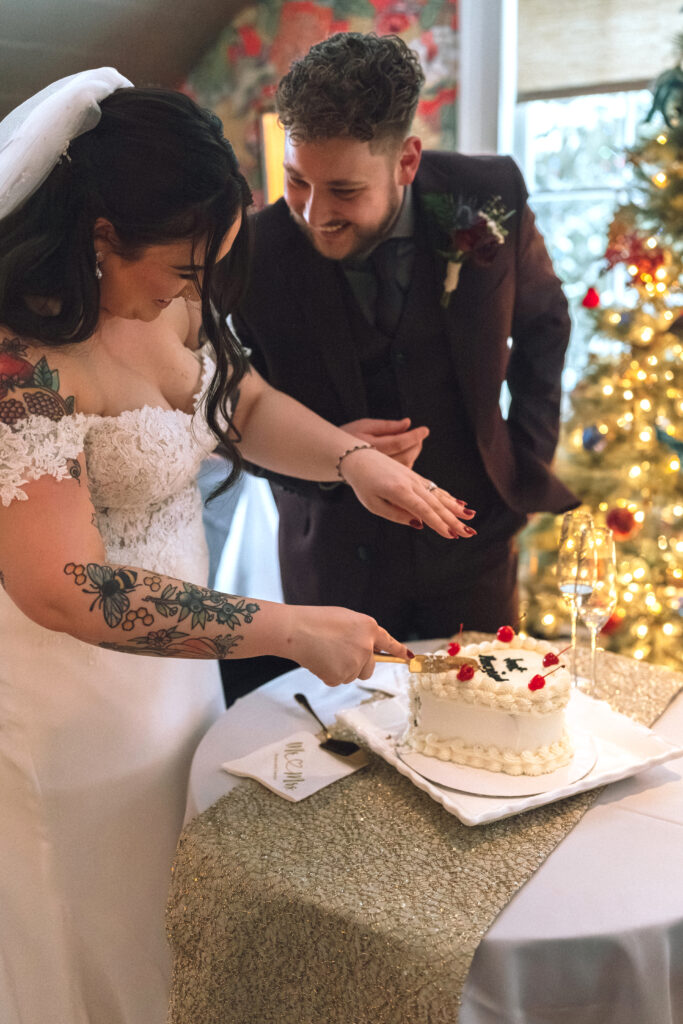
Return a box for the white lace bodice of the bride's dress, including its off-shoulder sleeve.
[0,346,216,582]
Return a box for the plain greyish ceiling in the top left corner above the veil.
[0,0,249,118]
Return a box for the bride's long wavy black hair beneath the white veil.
[0,88,252,490]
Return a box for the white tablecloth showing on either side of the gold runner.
[187,669,683,1024]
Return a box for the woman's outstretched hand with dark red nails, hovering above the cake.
[340,447,476,539]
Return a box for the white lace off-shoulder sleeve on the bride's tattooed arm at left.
[0,414,87,507]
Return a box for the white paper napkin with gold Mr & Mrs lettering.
[221,732,368,801]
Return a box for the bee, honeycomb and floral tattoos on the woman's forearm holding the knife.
[63,562,260,658]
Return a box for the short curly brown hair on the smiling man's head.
[275,32,425,144]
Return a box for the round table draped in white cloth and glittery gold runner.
[168,643,683,1024]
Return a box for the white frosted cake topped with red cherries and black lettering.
[404,627,573,775]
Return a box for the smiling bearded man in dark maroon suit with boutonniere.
[228,33,578,692]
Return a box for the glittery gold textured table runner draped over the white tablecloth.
[167,634,683,1024]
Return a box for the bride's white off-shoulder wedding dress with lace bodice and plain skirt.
[0,354,223,1024]
